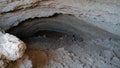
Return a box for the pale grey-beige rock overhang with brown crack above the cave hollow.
[0,0,120,36]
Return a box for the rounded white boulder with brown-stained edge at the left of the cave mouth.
[0,31,26,67]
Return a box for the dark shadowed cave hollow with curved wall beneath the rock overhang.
[7,14,115,49]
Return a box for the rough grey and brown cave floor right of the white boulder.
[21,31,120,68]
